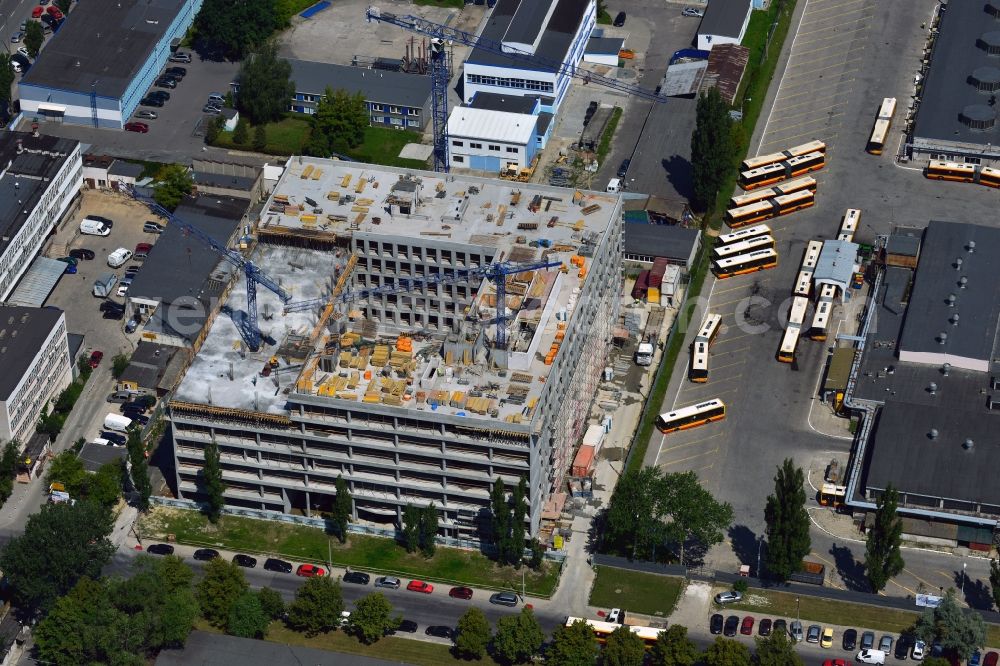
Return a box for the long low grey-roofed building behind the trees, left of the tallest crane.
[288,59,431,131]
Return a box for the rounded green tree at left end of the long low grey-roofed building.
[236,41,295,126]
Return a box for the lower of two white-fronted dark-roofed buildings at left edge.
[0,305,73,446]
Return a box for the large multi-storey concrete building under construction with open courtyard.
[170,158,622,538]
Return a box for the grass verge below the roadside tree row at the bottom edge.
[195,618,497,666]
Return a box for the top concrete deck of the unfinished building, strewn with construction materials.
[175,157,621,422]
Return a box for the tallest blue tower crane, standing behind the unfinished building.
[365,7,669,172]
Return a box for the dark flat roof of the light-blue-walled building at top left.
[21,0,185,99]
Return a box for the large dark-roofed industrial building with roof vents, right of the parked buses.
[848,221,1000,544]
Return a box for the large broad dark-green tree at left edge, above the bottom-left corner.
[0,500,115,614]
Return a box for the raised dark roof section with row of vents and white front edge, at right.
[899,220,1000,362]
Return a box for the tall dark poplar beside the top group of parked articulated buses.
[691,86,735,211]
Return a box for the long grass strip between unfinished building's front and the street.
[140,507,559,597]
